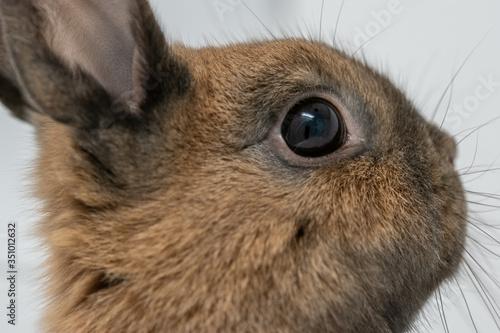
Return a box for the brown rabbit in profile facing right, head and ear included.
[0,0,467,333]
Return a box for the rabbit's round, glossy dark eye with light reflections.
[281,98,347,157]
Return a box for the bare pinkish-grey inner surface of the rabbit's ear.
[38,0,145,103]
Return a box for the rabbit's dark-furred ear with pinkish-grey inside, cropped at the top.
[0,0,189,127]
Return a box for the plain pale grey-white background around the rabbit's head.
[0,0,500,333]
